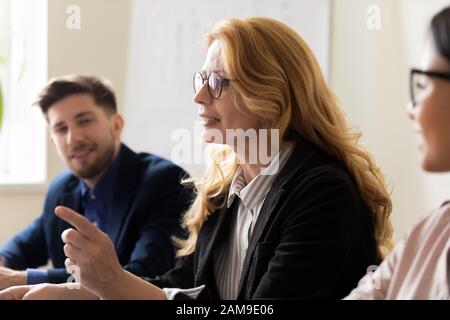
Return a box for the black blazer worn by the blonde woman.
[150,142,380,299]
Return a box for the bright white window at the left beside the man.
[0,0,47,185]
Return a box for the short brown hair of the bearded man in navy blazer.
[34,75,117,115]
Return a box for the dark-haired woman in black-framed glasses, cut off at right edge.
[347,7,450,299]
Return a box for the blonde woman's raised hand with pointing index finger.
[55,206,166,300]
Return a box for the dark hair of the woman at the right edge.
[430,7,450,62]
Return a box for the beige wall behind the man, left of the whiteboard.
[0,0,130,243]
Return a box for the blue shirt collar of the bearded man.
[80,144,122,203]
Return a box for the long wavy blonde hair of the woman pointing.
[178,17,392,258]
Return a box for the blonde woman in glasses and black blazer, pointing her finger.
[0,18,392,299]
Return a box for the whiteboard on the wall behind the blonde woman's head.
[123,0,331,175]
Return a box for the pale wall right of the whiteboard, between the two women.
[331,0,450,240]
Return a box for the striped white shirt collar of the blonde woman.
[227,144,295,210]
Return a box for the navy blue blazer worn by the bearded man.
[0,144,192,283]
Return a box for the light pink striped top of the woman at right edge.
[345,203,450,300]
